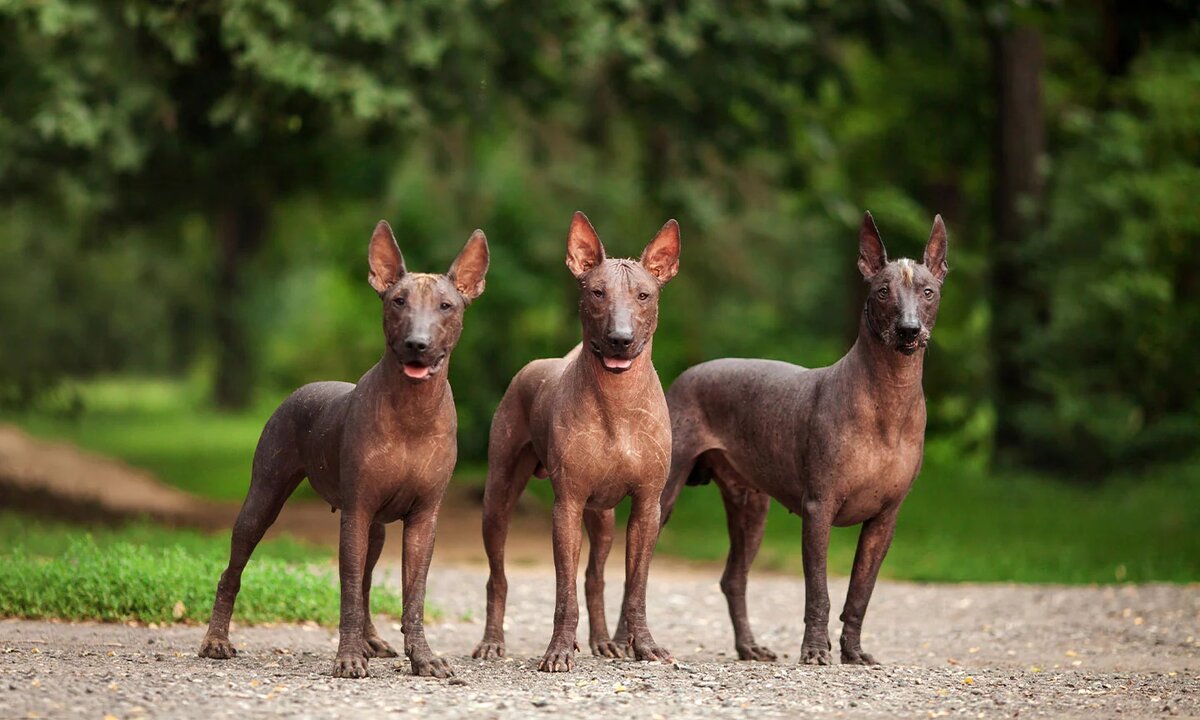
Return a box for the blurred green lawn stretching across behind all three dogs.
[9,379,1200,583]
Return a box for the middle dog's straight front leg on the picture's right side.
[622,494,673,662]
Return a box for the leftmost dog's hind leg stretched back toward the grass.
[199,439,304,660]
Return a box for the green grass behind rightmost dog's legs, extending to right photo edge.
[659,442,1200,583]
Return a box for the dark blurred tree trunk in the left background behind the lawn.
[212,200,266,409]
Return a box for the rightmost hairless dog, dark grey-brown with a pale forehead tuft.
[588,214,948,665]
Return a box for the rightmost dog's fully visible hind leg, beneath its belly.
[718,476,776,661]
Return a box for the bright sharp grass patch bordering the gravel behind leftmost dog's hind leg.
[0,512,401,625]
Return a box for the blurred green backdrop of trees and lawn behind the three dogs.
[0,0,1200,602]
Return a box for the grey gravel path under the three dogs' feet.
[0,564,1200,719]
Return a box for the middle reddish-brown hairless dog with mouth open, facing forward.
[474,212,679,672]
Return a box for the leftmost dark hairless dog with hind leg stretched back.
[200,221,488,678]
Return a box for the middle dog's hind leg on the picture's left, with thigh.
[472,395,538,660]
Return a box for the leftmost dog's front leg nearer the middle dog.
[400,503,454,678]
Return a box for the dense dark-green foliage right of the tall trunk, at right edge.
[1022,49,1200,475]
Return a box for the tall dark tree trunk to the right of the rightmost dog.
[990,25,1045,456]
